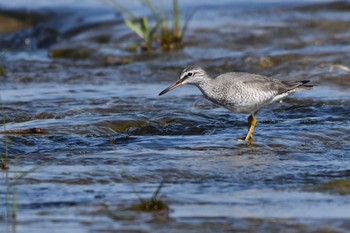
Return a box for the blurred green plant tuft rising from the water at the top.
[101,0,193,51]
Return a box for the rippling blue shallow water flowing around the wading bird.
[0,1,350,232]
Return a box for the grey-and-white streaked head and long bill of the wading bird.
[159,66,208,95]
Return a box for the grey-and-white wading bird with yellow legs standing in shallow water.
[159,66,314,143]
